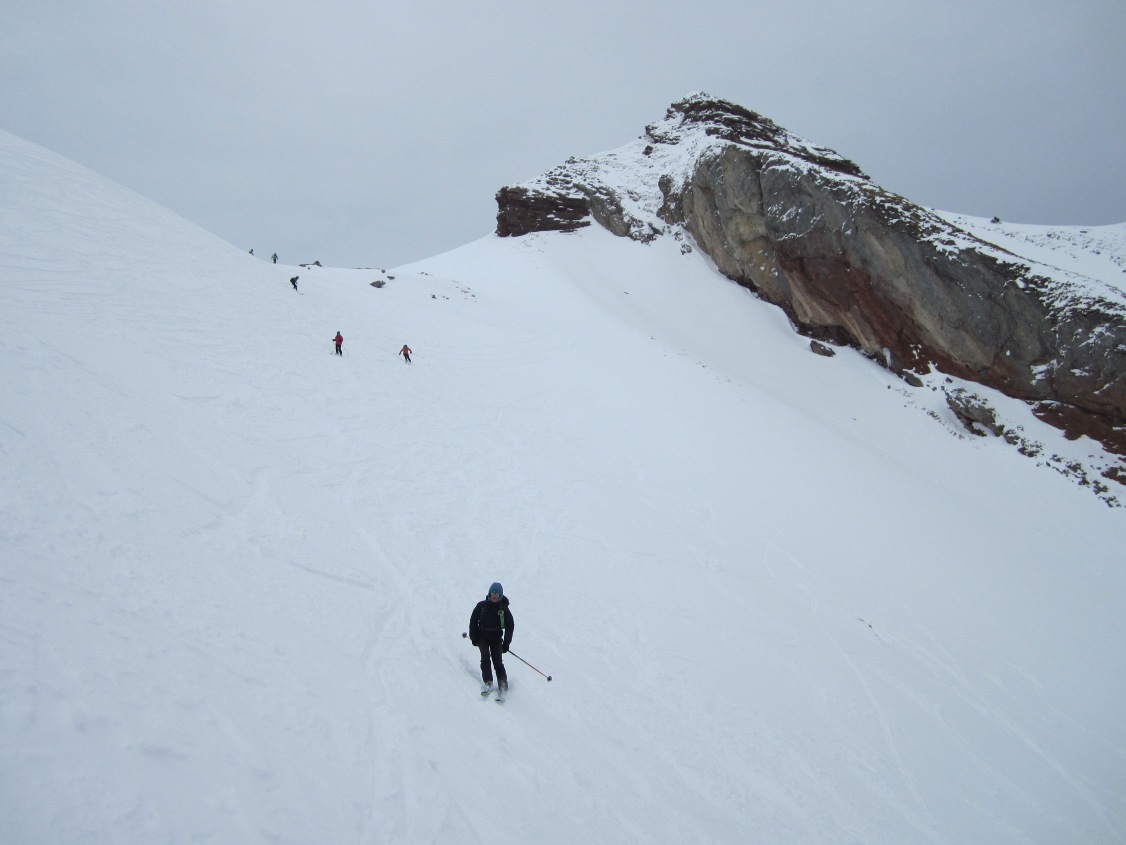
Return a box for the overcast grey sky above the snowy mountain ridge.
[0,0,1126,267]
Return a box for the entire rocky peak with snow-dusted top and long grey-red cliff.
[497,95,1126,454]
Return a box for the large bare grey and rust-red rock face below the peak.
[667,136,1126,450]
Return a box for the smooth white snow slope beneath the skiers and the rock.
[0,129,1126,845]
